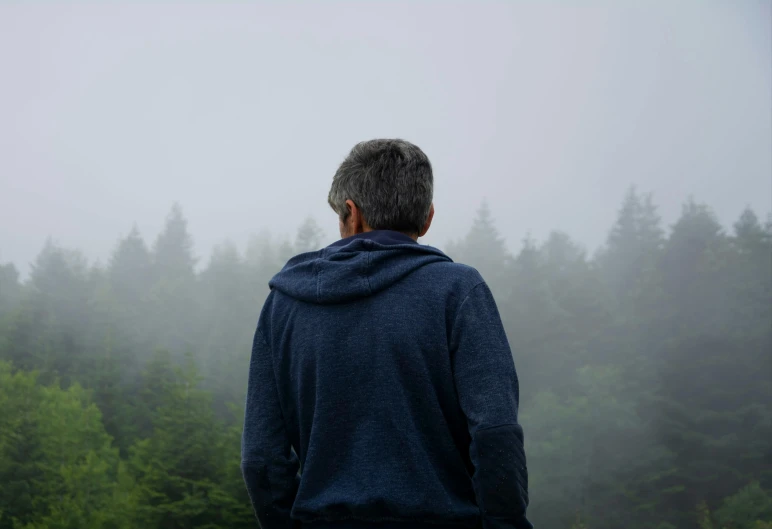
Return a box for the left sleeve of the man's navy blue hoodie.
[241,328,299,529]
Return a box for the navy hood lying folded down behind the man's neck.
[268,230,452,304]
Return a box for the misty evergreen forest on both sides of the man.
[0,189,772,529]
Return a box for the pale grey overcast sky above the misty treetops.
[0,1,772,271]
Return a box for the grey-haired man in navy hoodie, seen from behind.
[242,140,532,529]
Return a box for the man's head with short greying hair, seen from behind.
[327,140,434,238]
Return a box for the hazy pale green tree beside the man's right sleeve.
[521,366,652,527]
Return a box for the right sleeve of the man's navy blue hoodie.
[451,282,533,529]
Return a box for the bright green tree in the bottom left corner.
[0,363,134,529]
